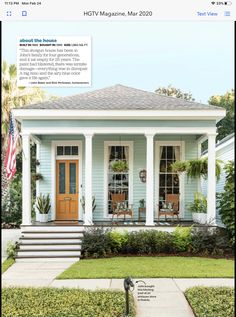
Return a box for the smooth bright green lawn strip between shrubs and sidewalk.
[57,256,234,279]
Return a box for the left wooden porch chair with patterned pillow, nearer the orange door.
[111,194,133,222]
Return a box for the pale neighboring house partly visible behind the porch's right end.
[201,133,235,225]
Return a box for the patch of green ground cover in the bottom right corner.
[185,287,234,317]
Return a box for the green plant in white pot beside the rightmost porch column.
[189,193,207,224]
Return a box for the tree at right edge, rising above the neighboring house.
[208,89,234,141]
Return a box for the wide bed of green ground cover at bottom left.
[1,287,135,317]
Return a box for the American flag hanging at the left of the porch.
[5,114,18,180]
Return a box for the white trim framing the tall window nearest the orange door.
[103,141,134,218]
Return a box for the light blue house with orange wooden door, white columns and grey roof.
[13,85,225,226]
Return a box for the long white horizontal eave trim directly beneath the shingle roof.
[13,109,226,121]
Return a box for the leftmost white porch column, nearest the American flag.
[22,134,31,225]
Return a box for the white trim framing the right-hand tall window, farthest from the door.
[154,141,185,218]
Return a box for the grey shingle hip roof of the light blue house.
[22,85,222,110]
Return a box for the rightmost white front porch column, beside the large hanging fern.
[207,134,216,224]
